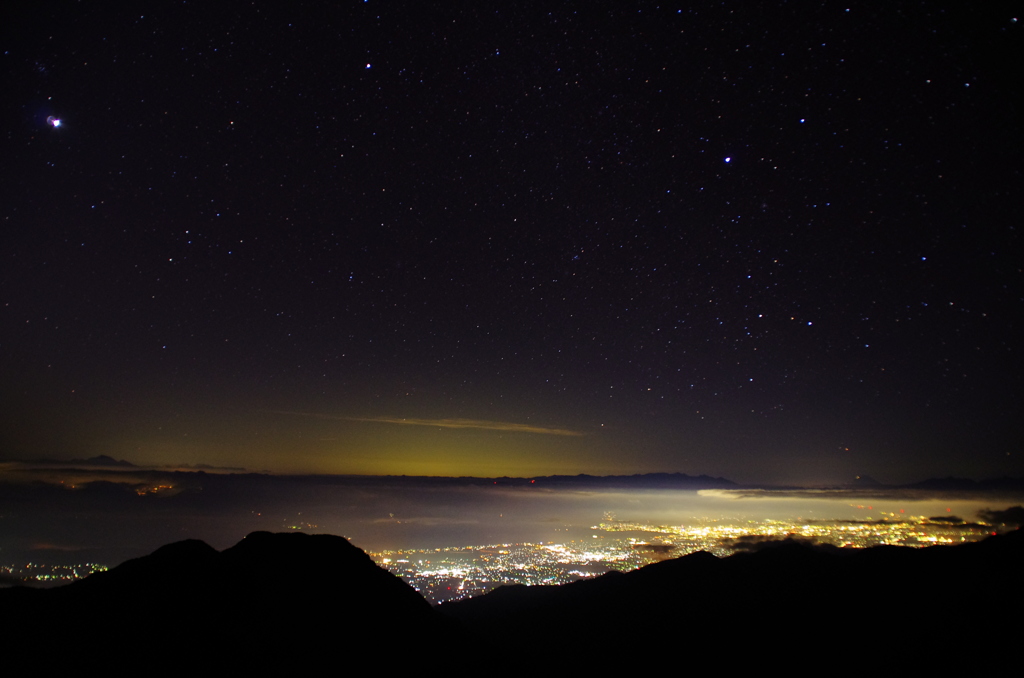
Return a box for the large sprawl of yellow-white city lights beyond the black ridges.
[370,515,994,604]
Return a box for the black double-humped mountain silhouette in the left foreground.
[0,533,451,675]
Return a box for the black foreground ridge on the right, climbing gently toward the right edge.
[440,532,1024,671]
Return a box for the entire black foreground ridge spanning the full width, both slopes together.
[0,531,1024,674]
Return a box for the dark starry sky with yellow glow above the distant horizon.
[0,0,1024,482]
